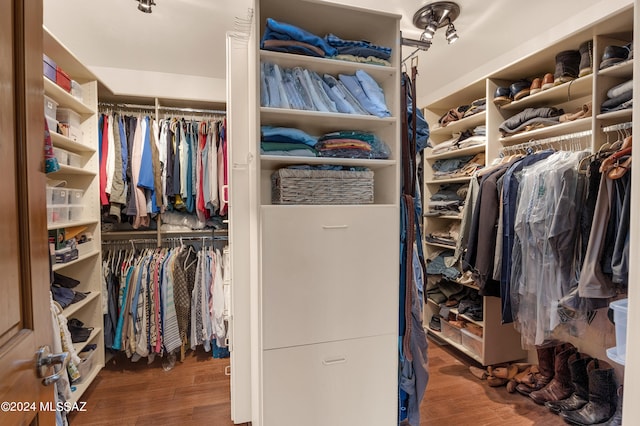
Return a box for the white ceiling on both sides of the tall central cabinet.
[44,0,632,104]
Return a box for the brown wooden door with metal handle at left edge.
[0,0,55,425]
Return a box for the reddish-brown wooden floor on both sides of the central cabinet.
[70,341,564,426]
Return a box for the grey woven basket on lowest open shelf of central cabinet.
[271,169,373,204]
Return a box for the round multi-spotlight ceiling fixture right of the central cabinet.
[410,1,460,50]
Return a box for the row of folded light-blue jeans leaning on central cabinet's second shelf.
[260,62,391,117]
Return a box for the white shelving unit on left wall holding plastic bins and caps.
[43,28,105,402]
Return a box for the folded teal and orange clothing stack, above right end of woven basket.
[315,130,391,159]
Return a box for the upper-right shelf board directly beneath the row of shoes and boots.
[500,74,593,111]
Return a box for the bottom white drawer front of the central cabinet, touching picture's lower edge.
[263,335,398,426]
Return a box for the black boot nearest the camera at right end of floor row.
[560,359,617,425]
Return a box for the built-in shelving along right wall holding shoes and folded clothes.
[424,6,637,370]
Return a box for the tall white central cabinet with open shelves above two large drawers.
[227,0,401,426]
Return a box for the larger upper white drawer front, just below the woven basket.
[262,206,399,349]
